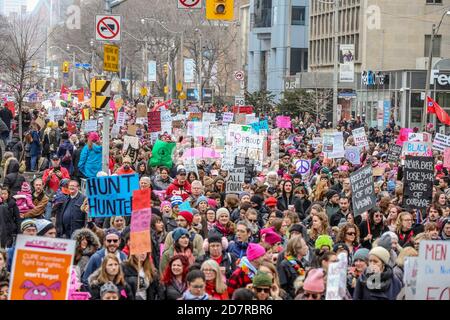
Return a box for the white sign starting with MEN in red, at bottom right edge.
[415,240,450,300]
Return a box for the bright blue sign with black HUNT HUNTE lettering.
[86,174,139,218]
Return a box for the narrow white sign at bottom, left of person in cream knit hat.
[325,252,348,300]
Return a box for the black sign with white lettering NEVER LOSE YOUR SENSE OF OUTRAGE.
[403,156,434,209]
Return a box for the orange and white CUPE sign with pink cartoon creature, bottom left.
[9,234,75,300]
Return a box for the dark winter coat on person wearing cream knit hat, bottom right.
[353,266,402,300]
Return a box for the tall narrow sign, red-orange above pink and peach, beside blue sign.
[130,189,152,254]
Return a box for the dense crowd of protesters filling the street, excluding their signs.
[0,97,450,300]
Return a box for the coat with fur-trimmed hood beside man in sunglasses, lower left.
[72,228,101,275]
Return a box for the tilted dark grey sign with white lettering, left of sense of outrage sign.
[350,166,377,216]
